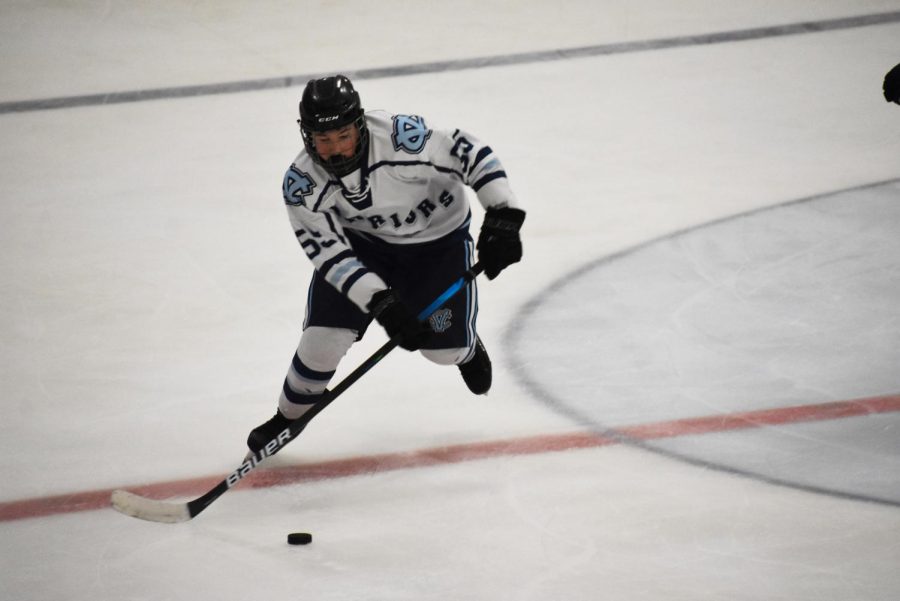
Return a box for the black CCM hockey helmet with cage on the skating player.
[297,75,369,177]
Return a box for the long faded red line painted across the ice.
[0,394,900,522]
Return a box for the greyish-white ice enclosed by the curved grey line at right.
[505,180,900,505]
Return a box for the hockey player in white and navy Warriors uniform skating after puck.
[247,75,525,451]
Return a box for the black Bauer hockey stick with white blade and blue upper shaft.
[111,263,484,524]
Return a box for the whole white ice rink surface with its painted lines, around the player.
[0,0,900,601]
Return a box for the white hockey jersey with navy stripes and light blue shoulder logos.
[282,111,518,311]
